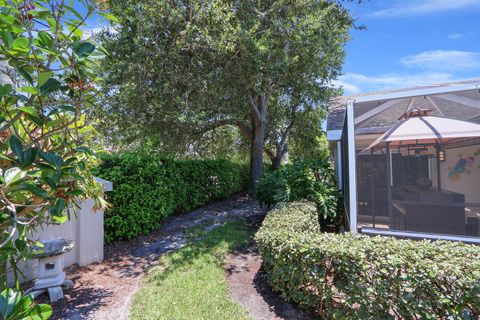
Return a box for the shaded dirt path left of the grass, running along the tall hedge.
[48,197,265,320]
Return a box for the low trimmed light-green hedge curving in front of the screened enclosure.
[256,203,480,319]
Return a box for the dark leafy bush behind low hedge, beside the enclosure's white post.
[256,161,338,222]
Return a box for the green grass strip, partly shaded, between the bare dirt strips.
[130,221,254,320]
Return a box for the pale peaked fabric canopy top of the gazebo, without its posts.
[367,116,480,149]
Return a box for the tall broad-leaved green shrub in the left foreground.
[0,0,109,298]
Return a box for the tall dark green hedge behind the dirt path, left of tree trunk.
[96,152,247,242]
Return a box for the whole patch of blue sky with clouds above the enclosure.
[337,0,480,95]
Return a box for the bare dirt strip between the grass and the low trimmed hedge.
[226,244,313,320]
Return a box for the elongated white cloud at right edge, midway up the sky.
[400,50,480,71]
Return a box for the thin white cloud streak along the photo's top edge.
[372,0,480,17]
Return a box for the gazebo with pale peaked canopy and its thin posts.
[367,109,480,225]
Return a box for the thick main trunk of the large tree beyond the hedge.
[249,96,268,196]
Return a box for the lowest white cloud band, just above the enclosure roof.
[338,72,459,95]
